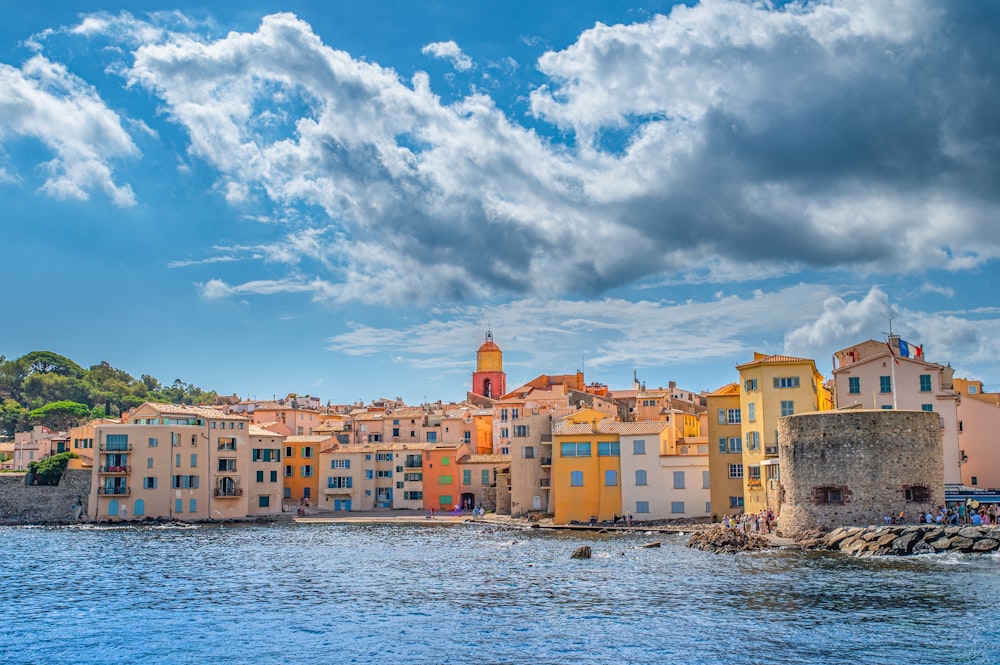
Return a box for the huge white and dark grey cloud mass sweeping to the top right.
[62,0,1000,302]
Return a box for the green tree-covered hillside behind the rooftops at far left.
[0,351,216,438]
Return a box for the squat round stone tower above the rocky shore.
[778,409,945,535]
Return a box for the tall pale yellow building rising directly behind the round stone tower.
[736,353,833,513]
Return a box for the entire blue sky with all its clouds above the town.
[0,0,1000,403]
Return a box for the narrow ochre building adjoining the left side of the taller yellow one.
[706,383,746,521]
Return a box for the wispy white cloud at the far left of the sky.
[0,55,139,206]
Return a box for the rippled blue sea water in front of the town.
[0,524,1000,664]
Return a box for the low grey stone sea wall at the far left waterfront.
[0,469,91,524]
